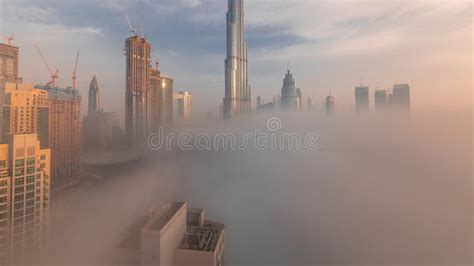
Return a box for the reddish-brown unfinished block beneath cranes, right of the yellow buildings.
[36,86,81,187]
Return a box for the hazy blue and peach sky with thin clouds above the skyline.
[0,0,473,115]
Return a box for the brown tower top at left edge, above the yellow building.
[0,43,22,82]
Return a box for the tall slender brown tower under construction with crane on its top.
[125,35,151,147]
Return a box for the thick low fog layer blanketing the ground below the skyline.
[48,109,473,266]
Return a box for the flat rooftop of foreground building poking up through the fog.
[116,202,225,266]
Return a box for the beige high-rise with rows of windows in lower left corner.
[0,134,50,265]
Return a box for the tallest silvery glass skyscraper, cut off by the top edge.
[223,0,251,119]
